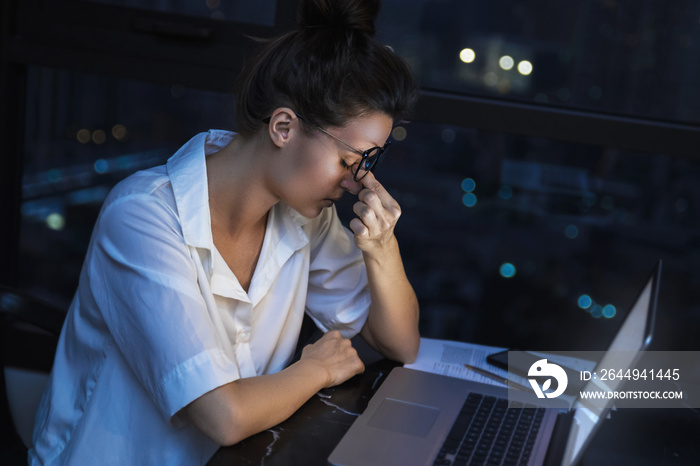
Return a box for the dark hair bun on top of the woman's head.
[298,0,381,36]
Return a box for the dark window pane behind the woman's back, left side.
[19,67,233,308]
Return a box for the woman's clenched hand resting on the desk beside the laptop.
[299,330,365,388]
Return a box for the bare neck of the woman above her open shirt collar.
[207,136,279,238]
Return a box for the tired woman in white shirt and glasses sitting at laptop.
[30,0,420,465]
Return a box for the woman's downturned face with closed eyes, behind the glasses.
[279,113,393,218]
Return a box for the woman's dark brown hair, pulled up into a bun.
[236,0,416,137]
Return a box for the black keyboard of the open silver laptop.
[434,393,544,466]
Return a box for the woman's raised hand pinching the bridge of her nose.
[350,172,401,253]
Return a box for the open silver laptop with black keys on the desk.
[328,261,661,466]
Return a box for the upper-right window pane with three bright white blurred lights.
[378,0,700,124]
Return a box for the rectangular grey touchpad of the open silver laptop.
[367,398,440,437]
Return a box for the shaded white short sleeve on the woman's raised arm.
[306,207,370,338]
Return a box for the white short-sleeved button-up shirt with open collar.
[29,131,369,466]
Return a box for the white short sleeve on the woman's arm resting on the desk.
[86,194,239,419]
